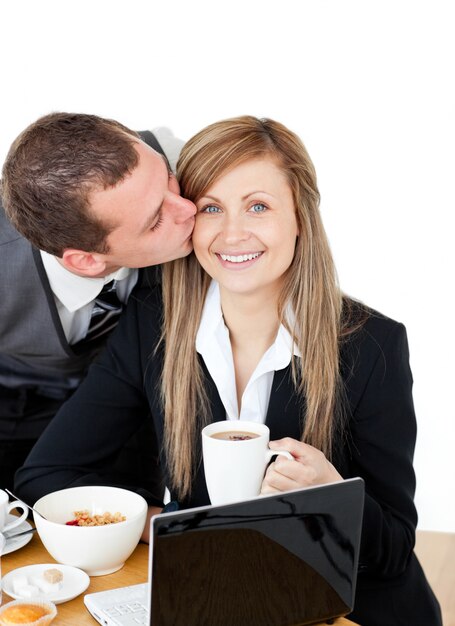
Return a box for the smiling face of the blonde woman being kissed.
[193,158,299,295]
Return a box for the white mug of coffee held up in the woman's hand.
[202,420,293,504]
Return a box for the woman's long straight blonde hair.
[161,116,358,497]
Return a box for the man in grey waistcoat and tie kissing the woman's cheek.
[0,113,195,488]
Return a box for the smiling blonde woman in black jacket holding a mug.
[18,116,441,626]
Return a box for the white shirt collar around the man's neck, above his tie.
[40,250,131,312]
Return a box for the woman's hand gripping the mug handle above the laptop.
[261,437,343,494]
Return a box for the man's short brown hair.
[1,113,139,257]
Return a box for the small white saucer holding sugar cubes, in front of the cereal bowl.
[2,563,90,604]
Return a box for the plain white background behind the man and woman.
[0,0,455,531]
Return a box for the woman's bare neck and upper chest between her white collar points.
[221,290,279,412]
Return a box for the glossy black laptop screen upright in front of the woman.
[150,478,364,626]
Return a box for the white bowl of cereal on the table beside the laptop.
[33,487,147,576]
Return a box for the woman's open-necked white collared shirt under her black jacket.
[196,281,300,423]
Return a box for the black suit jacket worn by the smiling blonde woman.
[16,288,441,626]
